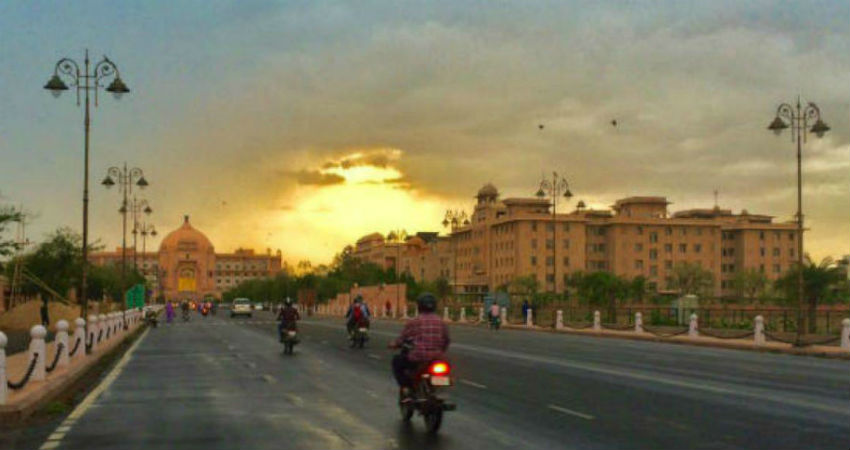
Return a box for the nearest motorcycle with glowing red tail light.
[398,342,457,434]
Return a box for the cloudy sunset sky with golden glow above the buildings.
[0,0,850,263]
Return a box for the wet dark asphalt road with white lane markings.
[19,311,850,450]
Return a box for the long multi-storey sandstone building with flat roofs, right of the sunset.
[344,184,798,296]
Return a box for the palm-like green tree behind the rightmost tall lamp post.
[776,255,848,333]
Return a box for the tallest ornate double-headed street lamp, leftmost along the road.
[44,50,130,317]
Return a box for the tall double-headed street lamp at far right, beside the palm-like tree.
[767,97,829,346]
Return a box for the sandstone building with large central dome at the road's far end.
[90,216,282,301]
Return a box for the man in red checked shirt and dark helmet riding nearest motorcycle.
[389,292,449,396]
